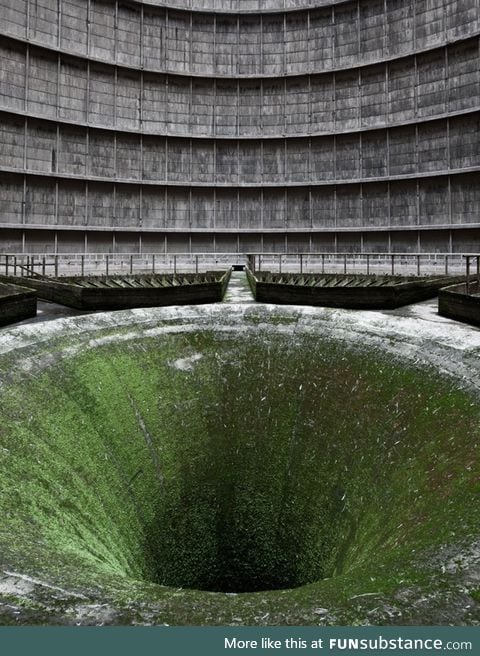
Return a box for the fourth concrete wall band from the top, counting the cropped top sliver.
[0,113,480,187]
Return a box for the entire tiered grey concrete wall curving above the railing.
[0,0,480,253]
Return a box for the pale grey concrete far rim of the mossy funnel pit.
[0,303,480,391]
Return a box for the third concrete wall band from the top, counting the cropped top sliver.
[0,36,480,138]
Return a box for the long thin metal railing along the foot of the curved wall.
[0,252,472,277]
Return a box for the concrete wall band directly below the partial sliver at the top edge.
[2,0,479,77]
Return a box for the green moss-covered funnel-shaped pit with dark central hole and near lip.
[0,308,480,624]
